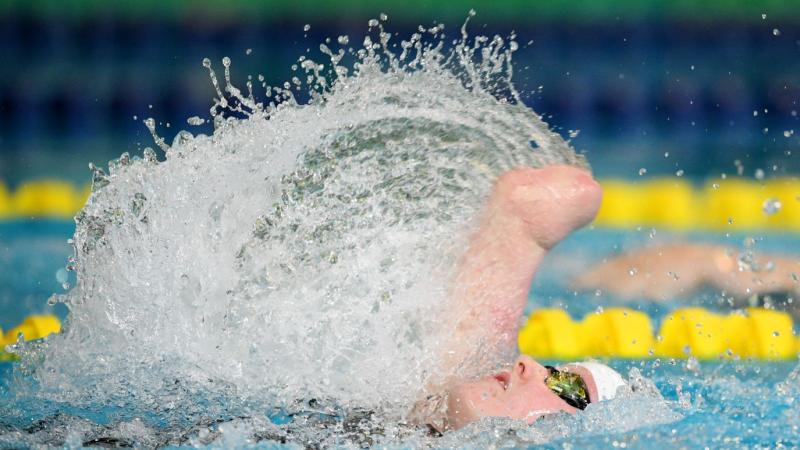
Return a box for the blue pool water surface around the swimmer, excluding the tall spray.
[0,222,800,448]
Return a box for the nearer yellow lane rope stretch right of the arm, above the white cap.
[518,308,800,360]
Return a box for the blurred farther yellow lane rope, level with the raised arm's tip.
[0,177,800,232]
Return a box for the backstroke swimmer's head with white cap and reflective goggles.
[447,356,625,429]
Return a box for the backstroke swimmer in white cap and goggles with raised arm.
[411,166,624,432]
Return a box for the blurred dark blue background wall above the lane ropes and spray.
[0,0,800,185]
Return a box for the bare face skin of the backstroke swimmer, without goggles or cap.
[447,356,598,429]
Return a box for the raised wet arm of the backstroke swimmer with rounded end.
[453,166,602,353]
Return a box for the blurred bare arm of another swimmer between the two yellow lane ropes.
[574,243,800,301]
